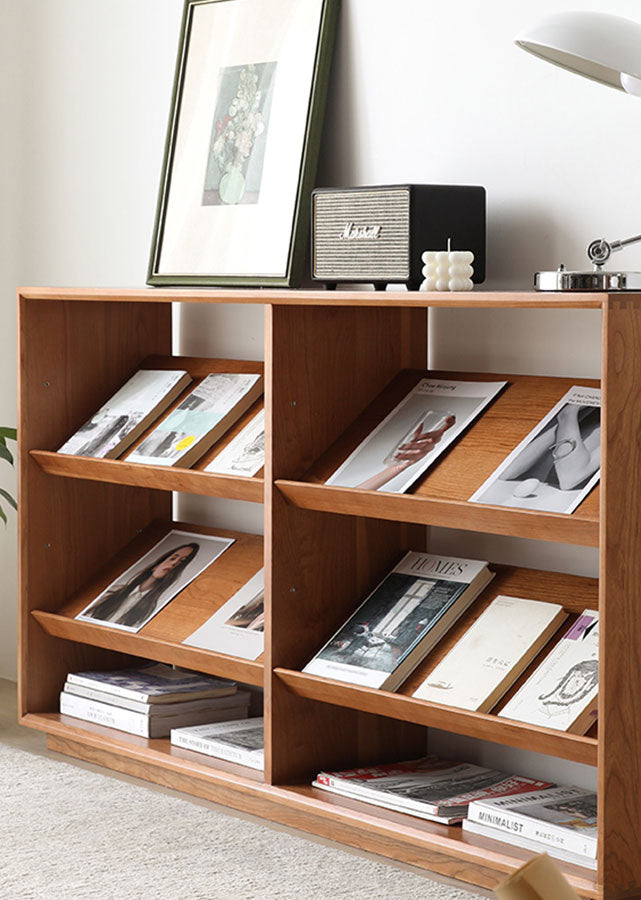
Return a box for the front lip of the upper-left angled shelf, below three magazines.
[30,450,265,503]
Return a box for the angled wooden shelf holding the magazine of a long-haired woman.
[31,522,264,687]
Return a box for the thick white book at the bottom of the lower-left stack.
[60,691,249,738]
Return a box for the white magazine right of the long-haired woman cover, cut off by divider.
[183,569,265,659]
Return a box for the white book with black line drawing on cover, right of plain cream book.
[499,609,599,734]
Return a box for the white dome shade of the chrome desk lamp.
[515,12,641,96]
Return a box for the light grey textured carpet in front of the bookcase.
[0,682,492,900]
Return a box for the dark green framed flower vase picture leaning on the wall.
[147,0,340,287]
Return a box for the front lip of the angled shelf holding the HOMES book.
[274,668,598,766]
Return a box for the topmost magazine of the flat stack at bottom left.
[67,663,237,703]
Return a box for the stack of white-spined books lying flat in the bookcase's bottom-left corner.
[60,663,250,738]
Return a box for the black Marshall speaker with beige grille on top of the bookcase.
[312,184,485,291]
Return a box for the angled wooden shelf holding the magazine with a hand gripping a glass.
[276,371,599,547]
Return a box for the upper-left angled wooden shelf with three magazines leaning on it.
[30,356,265,503]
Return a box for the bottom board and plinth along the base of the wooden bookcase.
[21,713,599,900]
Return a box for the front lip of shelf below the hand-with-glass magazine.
[275,479,599,547]
